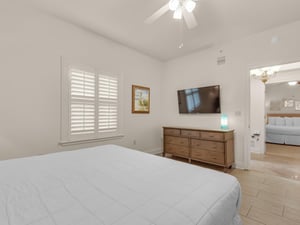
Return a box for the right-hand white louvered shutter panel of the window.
[98,75,118,132]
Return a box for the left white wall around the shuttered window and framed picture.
[0,0,162,159]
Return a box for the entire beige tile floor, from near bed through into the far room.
[241,144,300,225]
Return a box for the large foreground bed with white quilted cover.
[0,145,241,225]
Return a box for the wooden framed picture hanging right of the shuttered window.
[132,85,150,113]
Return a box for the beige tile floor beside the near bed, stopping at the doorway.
[231,170,300,225]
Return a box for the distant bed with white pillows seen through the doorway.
[266,114,300,145]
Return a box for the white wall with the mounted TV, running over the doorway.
[162,22,300,167]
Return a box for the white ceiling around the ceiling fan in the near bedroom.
[30,0,300,60]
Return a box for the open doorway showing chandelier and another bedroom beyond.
[249,63,300,180]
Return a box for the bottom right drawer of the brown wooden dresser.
[191,149,224,165]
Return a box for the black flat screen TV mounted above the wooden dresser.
[177,85,221,113]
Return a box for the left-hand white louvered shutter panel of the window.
[69,69,96,135]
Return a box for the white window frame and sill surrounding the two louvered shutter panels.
[60,59,124,145]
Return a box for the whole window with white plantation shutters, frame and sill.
[61,62,122,144]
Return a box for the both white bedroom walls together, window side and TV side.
[0,0,300,167]
